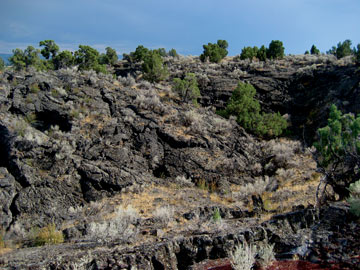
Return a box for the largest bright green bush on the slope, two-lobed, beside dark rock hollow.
[218,82,287,137]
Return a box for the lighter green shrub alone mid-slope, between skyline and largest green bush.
[173,73,200,104]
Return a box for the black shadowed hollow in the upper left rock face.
[33,111,72,132]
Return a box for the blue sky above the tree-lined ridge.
[0,0,360,55]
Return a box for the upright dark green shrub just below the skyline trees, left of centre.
[142,51,168,82]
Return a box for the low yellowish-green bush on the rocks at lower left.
[31,223,64,246]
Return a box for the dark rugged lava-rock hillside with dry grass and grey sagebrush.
[0,57,359,269]
